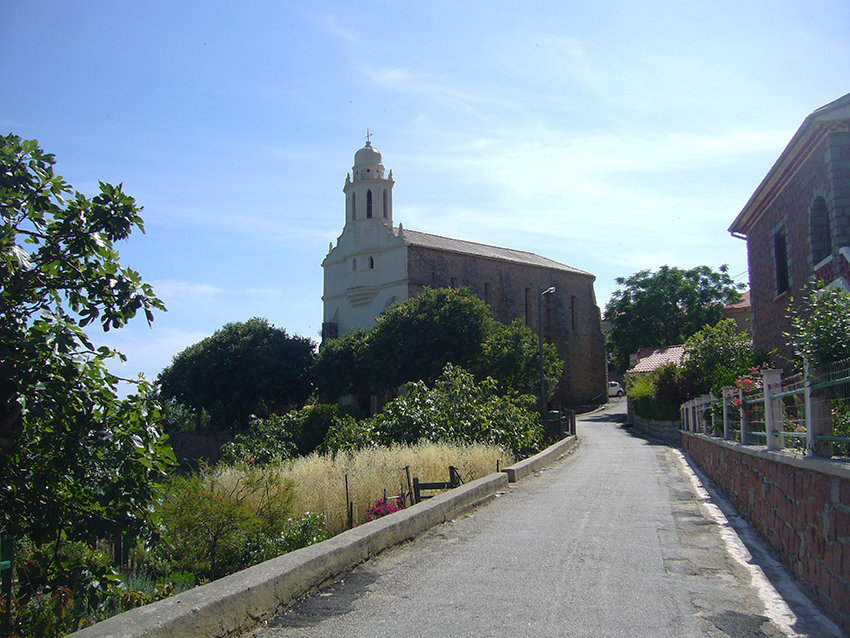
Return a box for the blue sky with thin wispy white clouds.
[0,0,850,379]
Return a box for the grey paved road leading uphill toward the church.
[247,400,843,638]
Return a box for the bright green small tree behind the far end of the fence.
[682,319,763,398]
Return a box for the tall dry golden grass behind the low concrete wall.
[212,443,513,534]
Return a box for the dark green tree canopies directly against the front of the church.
[315,288,563,401]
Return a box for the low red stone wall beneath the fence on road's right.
[681,432,850,632]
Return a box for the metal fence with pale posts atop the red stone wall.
[681,359,850,457]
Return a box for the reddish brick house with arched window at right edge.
[729,94,850,370]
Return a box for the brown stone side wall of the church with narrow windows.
[407,247,608,407]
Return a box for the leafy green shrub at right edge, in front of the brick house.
[787,287,850,368]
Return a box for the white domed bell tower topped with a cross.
[342,130,394,228]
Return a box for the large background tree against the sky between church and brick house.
[604,265,744,371]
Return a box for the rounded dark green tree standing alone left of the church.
[157,318,315,429]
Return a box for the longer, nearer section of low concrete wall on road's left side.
[71,470,506,638]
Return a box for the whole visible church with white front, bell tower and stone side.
[322,142,608,407]
